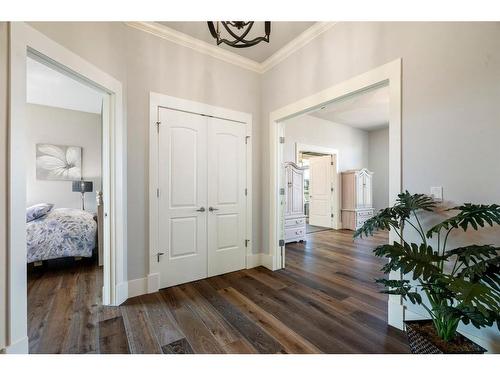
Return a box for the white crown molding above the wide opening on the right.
[260,22,337,73]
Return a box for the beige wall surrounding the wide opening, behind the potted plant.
[262,22,500,351]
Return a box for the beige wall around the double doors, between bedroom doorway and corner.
[31,22,262,280]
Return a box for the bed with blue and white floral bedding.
[26,208,97,263]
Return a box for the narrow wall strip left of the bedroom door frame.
[0,22,8,352]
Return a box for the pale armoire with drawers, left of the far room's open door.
[284,162,306,243]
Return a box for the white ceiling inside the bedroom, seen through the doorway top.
[26,58,103,114]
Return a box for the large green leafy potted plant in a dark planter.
[354,191,500,353]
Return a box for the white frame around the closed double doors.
[147,92,252,293]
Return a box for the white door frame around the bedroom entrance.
[7,22,128,353]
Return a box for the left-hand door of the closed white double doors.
[158,108,208,288]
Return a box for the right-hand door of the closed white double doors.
[208,118,246,277]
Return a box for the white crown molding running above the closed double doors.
[126,22,261,73]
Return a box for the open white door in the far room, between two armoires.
[309,155,333,228]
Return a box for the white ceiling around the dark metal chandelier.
[158,22,315,63]
